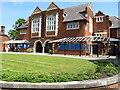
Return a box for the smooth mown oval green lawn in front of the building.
[0,54,96,74]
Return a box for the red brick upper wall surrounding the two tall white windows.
[18,9,85,45]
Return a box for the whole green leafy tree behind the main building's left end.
[8,18,25,40]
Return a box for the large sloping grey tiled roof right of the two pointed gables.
[63,3,92,22]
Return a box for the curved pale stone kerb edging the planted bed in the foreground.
[0,73,120,89]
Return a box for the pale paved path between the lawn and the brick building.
[0,52,120,66]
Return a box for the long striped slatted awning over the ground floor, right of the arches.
[49,36,120,43]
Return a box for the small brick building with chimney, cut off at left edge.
[0,26,9,52]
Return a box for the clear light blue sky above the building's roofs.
[0,2,118,34]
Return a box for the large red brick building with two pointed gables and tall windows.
[17,2,120,54]
